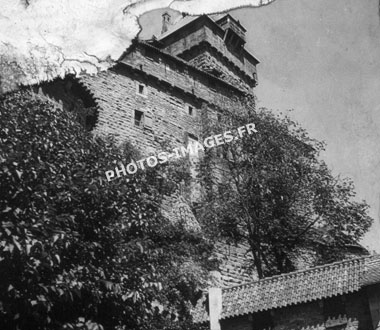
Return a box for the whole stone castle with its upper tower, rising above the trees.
[37,13,259,235]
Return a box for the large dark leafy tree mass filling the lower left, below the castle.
[0,91,210,329]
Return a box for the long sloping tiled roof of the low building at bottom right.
[193,255,380,322]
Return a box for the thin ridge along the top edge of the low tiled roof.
[223,254,380,291]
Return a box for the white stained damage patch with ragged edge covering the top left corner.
[0,0,274,93]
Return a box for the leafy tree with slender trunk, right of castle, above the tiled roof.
[200,100,372,278]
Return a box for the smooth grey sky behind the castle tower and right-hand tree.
[140,0,380,253]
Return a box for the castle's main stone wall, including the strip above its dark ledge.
[81,43,248,152]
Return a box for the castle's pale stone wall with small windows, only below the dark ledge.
[82,67,200,154]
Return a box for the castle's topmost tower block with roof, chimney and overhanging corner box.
[155,13,259,94]
